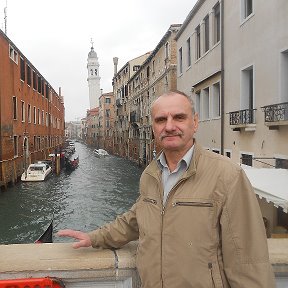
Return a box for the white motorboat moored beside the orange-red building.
[21,161,52,182]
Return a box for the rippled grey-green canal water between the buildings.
[0,142,142,244]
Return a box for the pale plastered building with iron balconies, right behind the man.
[176,0,288,232]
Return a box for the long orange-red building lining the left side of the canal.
[0,30,64,186]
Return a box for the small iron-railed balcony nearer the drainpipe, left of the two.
[229,109,256,131]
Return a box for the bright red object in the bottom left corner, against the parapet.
[0,277,65,288]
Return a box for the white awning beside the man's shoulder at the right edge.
[241,164,288,213]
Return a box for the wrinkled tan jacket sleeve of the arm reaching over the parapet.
[88,202,139,248]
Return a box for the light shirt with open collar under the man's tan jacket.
[157,145,194,205]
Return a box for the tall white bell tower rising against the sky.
[87,39,101,109]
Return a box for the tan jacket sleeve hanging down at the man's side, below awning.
[220,169,275,288]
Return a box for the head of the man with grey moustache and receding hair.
[152,93,198,152]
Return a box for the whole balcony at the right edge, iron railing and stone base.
[261,102,288,130]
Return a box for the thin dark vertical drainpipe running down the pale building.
[220,0,225,155]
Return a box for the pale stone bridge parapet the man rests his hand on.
[0,238,288,288]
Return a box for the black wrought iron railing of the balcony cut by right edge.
[261,102,288,122]
